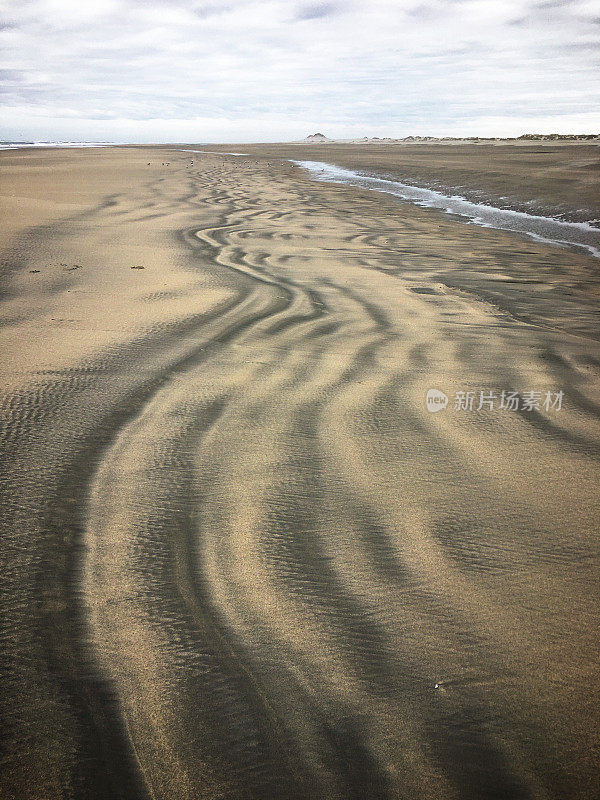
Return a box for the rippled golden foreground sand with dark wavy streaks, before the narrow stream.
[0,146,600,800]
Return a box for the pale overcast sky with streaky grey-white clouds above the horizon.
[0,0,600,142]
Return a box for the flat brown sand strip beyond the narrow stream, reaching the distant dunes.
[207,140,600,221]
